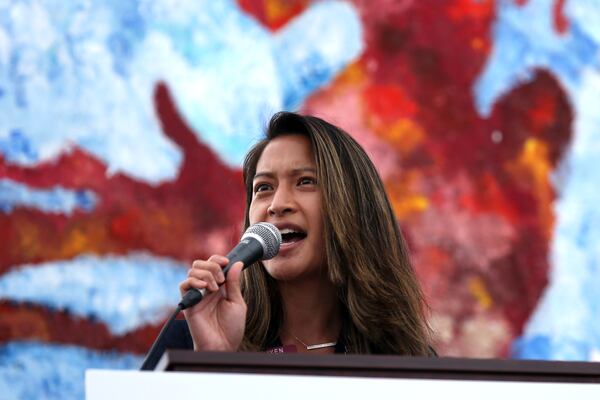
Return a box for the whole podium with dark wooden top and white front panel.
[86,350,600,400]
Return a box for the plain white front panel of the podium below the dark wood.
[85,370,600,400]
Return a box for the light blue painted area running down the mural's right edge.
[475,1,600,360]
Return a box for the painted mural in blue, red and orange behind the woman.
[0,0,600,398]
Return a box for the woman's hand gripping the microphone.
[179,255,247,351]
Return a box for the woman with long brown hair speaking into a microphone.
[180,112,432,355]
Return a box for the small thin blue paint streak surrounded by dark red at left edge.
[0,179,98,215]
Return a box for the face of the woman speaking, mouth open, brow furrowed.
[249,135,324,281]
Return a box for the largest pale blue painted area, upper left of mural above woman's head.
[0,0,363,183]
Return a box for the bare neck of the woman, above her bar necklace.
[279,279,341,351]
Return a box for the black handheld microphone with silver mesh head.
[179,222,281,310]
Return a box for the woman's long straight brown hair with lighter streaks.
[241,112,431,355]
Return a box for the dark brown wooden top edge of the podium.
[156,350,600,383]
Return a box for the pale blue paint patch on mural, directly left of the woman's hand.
[0,253,188,335]
